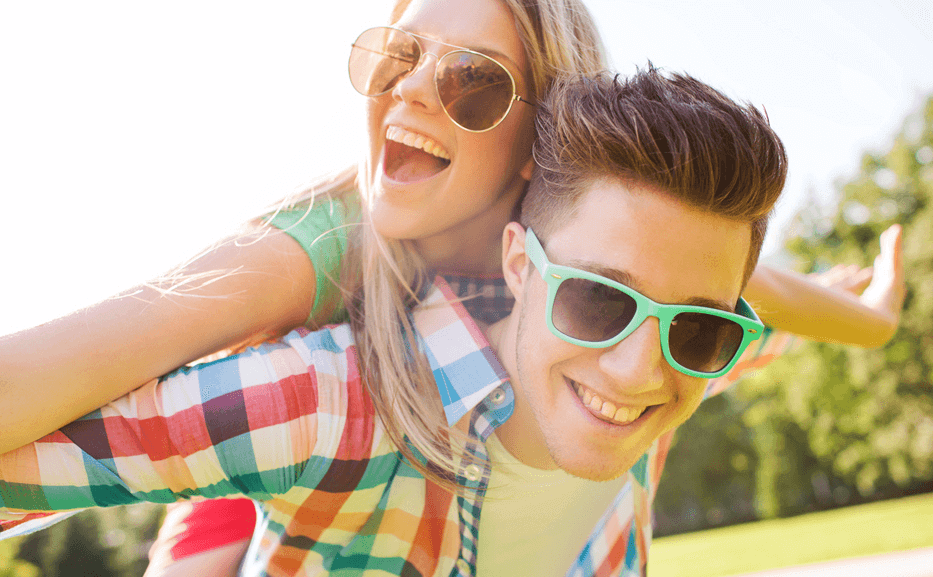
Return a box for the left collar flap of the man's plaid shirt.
[412,277,509,425]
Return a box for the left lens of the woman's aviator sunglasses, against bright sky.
[349,28,421,96]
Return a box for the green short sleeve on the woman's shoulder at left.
[268,198,355,322]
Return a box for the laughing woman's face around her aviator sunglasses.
[367,0,534,261]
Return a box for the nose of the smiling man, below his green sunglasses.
[599,317,668,395]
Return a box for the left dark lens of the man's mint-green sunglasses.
[551,278,636,343]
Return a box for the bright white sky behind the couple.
[0,0,933,334]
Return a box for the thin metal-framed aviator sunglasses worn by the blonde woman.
[349,26,533,132]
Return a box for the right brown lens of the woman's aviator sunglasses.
[435,51,515,130]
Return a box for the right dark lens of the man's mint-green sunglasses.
[669,313,744,373]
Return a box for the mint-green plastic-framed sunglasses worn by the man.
[525,228,764,378]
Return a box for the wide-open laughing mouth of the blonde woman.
[383,126,450,183]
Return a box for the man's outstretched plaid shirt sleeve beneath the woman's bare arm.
[0,325,363,527]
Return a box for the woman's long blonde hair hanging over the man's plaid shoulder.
[272,0,606,492]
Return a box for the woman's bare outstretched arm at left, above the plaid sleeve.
[0,227,316,453]
